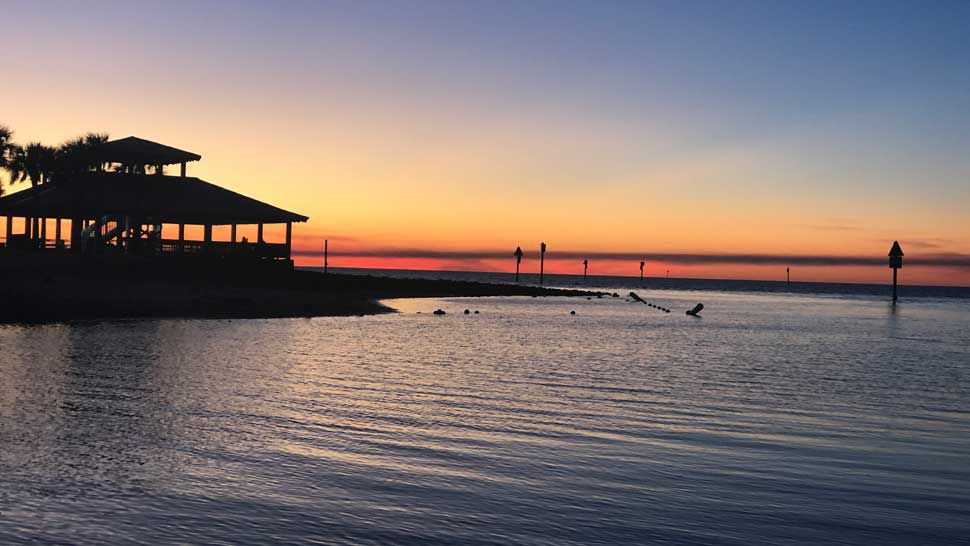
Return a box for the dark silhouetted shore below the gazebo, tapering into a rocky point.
[0,267,589,323]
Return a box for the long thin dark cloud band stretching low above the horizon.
[294,248,970,269]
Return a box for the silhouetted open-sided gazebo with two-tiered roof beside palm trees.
[0,137,308,264]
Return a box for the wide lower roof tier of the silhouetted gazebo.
[0,172,309,225]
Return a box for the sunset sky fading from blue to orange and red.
[0,0,970,285]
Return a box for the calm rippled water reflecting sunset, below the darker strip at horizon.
[0,282,970,545]
